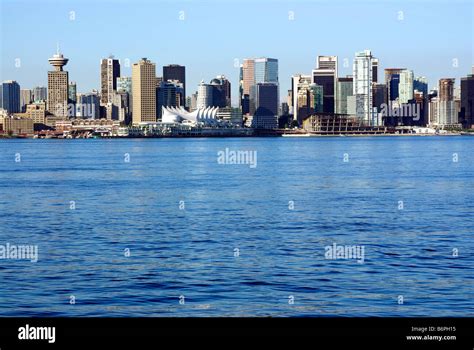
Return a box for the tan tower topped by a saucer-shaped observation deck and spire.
[48,49,69,117]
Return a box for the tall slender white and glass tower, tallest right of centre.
[353,50,375,126]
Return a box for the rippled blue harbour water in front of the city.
[0,137,474,317]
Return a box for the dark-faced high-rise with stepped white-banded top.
[312,56,338,113]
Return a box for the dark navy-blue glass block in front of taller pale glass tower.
[250,83,278,129]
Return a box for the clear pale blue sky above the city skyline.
[0,0,474,104]
